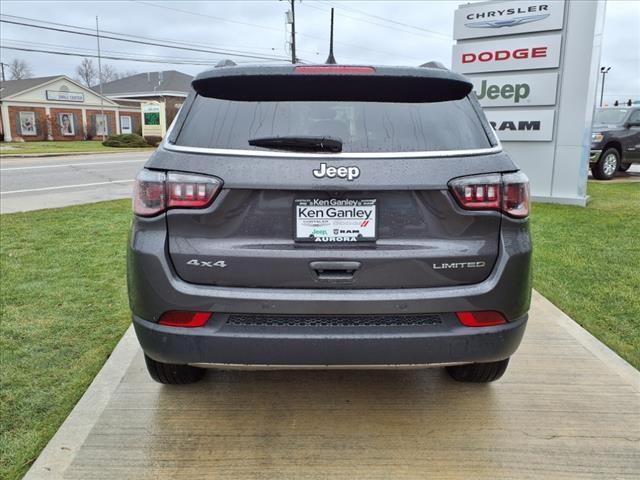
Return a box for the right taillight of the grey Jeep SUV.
[449,172,529,218]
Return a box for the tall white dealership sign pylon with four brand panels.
[452,0,605,205]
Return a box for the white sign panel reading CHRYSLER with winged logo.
[453,0,564,40]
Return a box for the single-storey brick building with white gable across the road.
[0,75,141,142]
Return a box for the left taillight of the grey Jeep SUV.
[133,169,222,217]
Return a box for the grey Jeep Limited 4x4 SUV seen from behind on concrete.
[128,65,531,383]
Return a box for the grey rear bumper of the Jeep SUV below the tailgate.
[128,217,531,367]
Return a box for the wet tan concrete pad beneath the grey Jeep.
[25,293,640,480]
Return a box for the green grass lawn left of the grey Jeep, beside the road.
[0,200,131,480]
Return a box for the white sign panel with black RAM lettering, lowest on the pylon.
[485,109,555,142]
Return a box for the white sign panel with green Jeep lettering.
[471,72,558,107]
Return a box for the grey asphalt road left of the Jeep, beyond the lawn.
[0,150,150,213]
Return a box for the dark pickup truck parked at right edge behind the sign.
[589,107,640,180]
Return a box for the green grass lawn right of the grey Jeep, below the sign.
[531,183,640,369]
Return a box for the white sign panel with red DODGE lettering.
[452,33,561,73]
